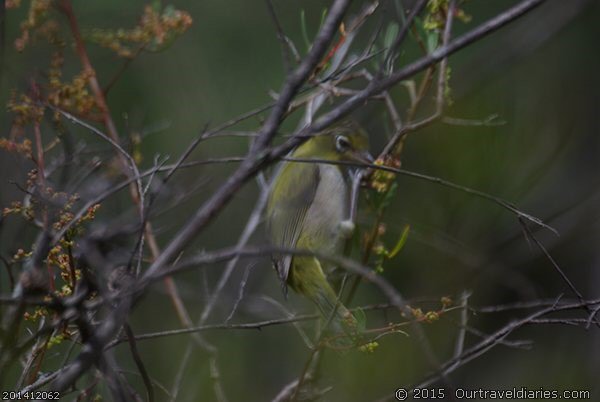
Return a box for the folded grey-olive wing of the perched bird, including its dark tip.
[267,162,320,294]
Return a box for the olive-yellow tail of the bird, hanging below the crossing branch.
[288,257,360,338]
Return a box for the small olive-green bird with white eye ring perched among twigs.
[266,123,373,333]
